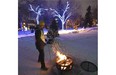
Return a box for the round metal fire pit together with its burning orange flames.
[56,52,73,71]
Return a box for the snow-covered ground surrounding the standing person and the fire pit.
[18,27,98,75]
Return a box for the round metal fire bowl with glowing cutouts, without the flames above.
[56,57,73,71]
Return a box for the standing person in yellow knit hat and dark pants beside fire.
[35,21,48,70]
